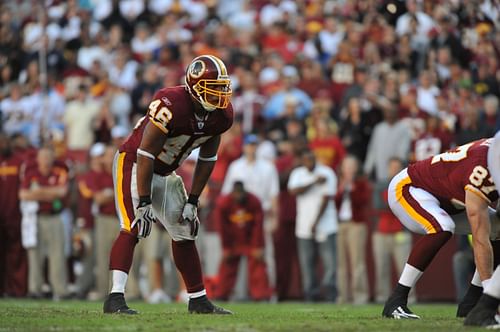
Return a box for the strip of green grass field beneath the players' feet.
[0,300,485,332]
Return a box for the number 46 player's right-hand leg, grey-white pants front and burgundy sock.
[152,174,232,314]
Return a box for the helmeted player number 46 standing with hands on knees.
[103,55,233,314]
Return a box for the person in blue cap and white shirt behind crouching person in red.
[221,134,279,298]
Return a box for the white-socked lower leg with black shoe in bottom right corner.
[464,266,500,328]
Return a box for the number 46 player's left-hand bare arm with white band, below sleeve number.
[137,121,166,197]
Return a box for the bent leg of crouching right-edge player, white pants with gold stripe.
[382,170,455,319]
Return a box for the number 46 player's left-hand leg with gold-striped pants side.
[103,153,138,314]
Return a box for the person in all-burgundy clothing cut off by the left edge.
[0,133,28,297]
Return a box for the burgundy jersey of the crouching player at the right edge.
[408,139,498,213]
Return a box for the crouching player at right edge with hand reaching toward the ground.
[382,139,498,319]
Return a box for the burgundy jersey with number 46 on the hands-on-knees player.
[119,86,233,175]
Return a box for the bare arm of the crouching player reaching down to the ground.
[465,190,493,281]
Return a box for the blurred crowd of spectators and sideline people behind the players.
[0,0,500,303]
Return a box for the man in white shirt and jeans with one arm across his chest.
[288,150,338,302]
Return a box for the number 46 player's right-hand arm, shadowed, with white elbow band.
[188,135,220,205]
